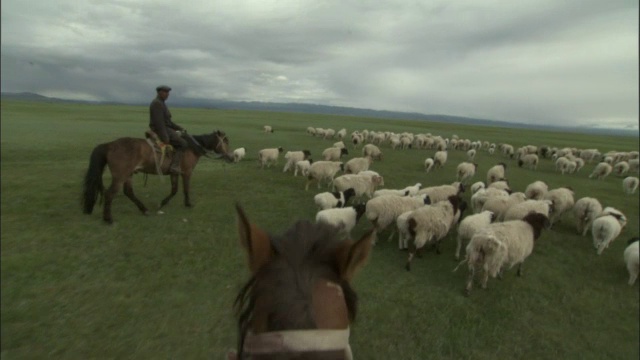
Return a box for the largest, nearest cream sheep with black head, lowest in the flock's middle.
[464,213,548,296]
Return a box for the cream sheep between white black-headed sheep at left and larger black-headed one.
[366,195,431,238]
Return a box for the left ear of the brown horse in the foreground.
[236,204,271,274]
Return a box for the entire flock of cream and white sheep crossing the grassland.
[229,126,640,294]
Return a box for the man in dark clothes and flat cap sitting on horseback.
[149,85,188,174]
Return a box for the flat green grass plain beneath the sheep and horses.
[1,101,640,359]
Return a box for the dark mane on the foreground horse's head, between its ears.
[234,221,357,354]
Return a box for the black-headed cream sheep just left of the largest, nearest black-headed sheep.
[406,195,462,271]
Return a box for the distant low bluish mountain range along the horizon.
[0,92,638,136]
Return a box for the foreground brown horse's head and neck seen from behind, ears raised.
[227,206,375,359]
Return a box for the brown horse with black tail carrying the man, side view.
[82,130,233,224]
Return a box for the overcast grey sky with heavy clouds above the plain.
[0,0,639,129]
